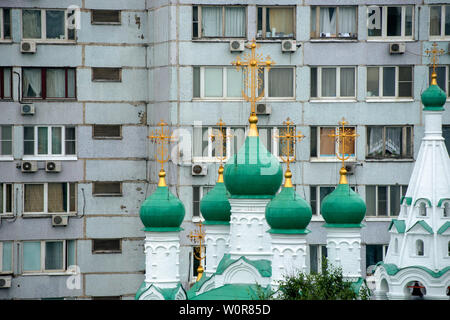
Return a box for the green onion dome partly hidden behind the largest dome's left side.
[200,166,231,224]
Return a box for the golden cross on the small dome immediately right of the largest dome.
[276,118,305,188]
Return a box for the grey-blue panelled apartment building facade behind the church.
[0,0,450,299]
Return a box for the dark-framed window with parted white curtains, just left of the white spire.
[366,126,414,159]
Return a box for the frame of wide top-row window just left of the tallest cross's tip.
[192,4,248,40]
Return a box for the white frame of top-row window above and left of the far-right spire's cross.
[366,5,415,41]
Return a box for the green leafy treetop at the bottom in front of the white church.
[258,259,371,300]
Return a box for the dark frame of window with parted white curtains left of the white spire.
[366,125,414,161]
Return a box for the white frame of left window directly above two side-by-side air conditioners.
[23,125,77,161]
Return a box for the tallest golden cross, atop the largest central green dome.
[231,39,275,136]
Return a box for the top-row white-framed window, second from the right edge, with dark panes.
[367,6,414,40]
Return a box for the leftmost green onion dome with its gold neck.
[140,170,185,232]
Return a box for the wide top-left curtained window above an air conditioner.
[22,9,75,41]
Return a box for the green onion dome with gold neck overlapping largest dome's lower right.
[266,171,312,233]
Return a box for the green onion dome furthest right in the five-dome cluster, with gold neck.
[321,168,366,228]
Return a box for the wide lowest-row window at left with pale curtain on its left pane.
[22,240,75,273]
